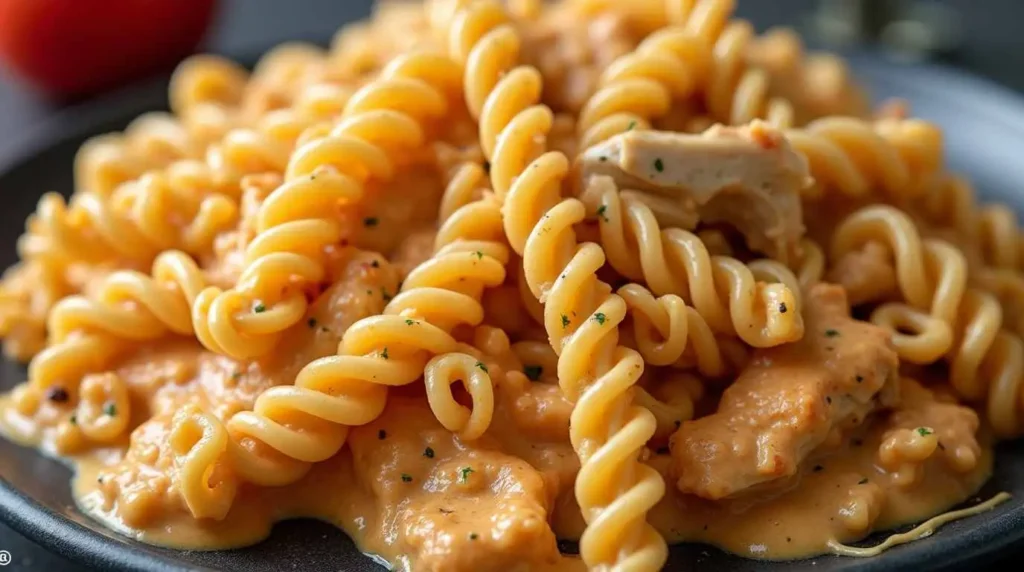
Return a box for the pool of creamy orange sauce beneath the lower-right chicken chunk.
[651,380,992,560]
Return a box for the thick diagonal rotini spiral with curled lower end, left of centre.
[193,52,461,359]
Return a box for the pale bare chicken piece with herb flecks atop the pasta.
[581,122,811,261]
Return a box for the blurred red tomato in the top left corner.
[0,0,216,96]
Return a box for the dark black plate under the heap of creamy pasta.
[0,56,1024,572]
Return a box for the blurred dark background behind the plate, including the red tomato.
[0,0,1024,572]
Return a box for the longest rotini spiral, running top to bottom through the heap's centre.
[450,2,668,570]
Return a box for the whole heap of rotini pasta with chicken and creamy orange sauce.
[0,0,1011,572]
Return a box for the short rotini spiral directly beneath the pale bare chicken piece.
[583,185,803,347]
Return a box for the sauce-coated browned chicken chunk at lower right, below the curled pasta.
[672,283,899,499]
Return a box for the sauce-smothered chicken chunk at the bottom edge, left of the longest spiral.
[349,397,559,572]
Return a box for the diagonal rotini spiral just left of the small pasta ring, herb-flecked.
[187,243,507,497]
